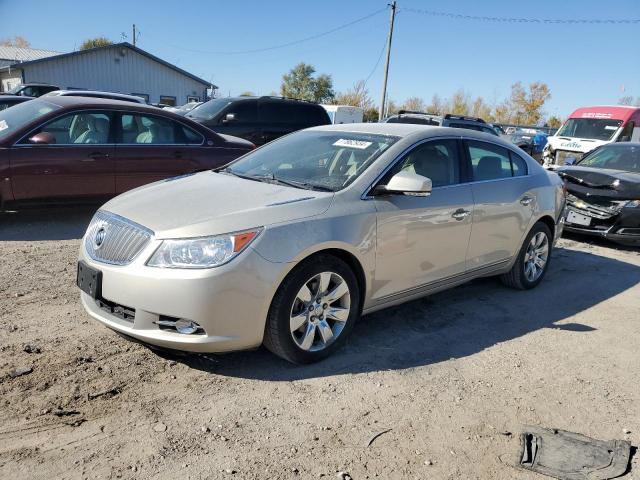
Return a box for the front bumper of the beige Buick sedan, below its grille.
[79,241,287,352]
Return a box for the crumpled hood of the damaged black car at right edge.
[555,165,640,200]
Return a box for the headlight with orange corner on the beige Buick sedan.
[147,228,262,268]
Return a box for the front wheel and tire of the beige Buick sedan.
[264,254,361,364]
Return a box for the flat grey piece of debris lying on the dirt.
[518,427,631,480]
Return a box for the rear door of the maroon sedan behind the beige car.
[115,112,216,194]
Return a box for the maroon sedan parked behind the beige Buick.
[0,96,255,207]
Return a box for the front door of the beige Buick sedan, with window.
[373,139,473,301]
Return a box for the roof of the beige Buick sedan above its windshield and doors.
[307,123,514,149]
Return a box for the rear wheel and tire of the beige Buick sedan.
[500,222,553,290]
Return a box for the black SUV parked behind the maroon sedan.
[186,97,331,145]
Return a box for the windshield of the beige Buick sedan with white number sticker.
[222,131,398,191]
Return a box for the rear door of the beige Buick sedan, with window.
[463,140,536,270]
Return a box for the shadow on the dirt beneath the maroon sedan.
[0,205,98,241]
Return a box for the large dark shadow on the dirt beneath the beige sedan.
[169,248,640,381]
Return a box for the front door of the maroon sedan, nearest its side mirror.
[10,111,115,201]
